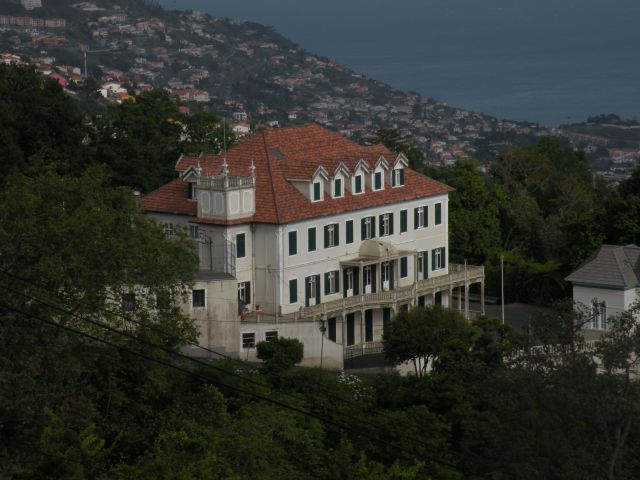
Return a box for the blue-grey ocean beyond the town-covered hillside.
[160,0,640,126]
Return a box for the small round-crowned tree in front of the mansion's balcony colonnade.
[382,305,465,377]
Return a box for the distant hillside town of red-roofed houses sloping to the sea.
[0,0,640,180]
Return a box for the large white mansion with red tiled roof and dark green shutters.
[142,125,484,368]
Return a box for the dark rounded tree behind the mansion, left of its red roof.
[94,90,185,192]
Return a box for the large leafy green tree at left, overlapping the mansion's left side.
[0,167,197,477]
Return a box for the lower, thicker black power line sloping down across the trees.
[0,299,456,469]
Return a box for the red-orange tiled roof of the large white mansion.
[143,124,453,225]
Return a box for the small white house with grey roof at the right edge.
[566,245,640,330]
